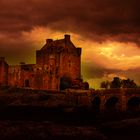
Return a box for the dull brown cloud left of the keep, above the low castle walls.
[0,38,35,64]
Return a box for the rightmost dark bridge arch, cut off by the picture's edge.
[127,96,140,111]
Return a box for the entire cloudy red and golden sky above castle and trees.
[0,0,140,88]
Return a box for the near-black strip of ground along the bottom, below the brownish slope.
[0,106,140,140]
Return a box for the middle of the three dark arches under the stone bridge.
[105,96,119,112]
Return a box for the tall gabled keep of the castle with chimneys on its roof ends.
[36,35,81,90]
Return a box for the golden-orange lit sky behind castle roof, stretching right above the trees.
[22,27,140,88]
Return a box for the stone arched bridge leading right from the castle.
[66,88,140,111]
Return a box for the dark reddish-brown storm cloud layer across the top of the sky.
[0,0,140,43]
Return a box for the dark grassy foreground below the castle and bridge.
[0,93,140,140]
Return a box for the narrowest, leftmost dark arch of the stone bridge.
[92,96,101,113]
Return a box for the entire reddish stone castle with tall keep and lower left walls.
[0,35,88,91]
